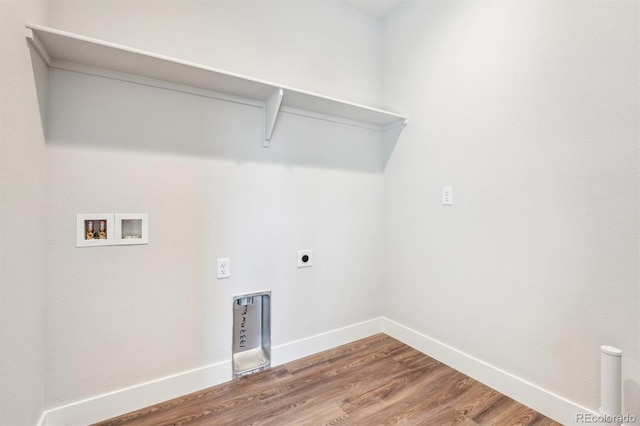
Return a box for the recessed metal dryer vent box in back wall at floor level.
[232,291,271,378]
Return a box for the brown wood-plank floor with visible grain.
[92,334,559,426]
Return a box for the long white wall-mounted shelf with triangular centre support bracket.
[26,24,407,146]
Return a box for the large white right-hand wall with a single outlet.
[383,1,640,415]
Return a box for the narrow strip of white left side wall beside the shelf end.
[0,0,47,426]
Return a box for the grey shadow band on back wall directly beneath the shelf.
[43,69,383,173]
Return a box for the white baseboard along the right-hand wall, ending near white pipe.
[382,318,597,425]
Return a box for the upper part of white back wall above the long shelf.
[50,0,382,106]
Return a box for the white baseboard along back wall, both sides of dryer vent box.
[45,318,382,426]
